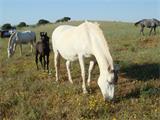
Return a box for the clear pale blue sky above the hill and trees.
[0,0,160,25]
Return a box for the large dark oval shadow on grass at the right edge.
[121,63,160,81]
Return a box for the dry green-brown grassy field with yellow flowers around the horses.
[0,22,160,120]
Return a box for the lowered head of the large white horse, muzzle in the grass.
[98,64,119,101]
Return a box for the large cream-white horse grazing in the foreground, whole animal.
[52,21,118,100]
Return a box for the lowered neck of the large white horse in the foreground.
[86,22,114,75]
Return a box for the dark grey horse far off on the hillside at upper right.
[134,18,160,35]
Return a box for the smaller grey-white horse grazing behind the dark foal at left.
[8,31,36,58]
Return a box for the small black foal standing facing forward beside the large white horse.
[35,32,50,72]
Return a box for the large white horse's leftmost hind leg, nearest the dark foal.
[54,51,60,81]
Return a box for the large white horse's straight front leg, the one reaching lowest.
[78,55,88,93]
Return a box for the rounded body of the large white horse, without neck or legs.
[52,24,92,61]
